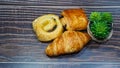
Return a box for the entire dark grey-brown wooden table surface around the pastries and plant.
[0,0,120,68]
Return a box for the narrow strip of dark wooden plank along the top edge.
[0,0,120,6]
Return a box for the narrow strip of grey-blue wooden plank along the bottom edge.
[0,62,120,68]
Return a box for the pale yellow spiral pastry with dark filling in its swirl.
[32,14,63,41]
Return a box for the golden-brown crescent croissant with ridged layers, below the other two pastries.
[45,31,91,56]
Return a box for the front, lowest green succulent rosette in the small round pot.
[90,22,110,39]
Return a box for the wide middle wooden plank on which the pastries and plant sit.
[0,4,120,62]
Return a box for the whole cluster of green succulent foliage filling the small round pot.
[90,12,112,40]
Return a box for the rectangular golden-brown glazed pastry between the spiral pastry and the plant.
[61,9,88,30]
